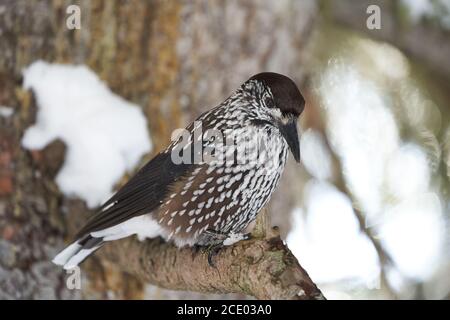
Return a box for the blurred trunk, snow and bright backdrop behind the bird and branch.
[0,0,450,299]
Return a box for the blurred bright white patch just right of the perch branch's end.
[286,179,380,288]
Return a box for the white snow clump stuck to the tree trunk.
[22,61,152,207]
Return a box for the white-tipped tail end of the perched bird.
[53,235,105,270]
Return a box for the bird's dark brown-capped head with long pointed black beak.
[243,72,305,162]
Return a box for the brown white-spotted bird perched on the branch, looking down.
[53,72,305,269]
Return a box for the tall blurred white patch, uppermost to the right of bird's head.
[318,61,401,225]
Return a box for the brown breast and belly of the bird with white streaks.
[154,123,287,245]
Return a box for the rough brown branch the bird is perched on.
[99,229,325,299]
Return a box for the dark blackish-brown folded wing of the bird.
[77,150,192,238]
